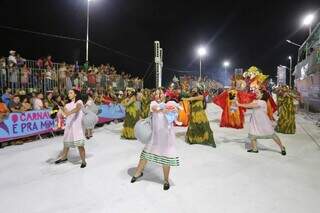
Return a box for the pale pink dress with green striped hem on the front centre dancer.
[140,101,179,166]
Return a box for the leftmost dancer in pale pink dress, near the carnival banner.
[55,89,87,168]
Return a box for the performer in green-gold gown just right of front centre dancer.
[183,88,216,148]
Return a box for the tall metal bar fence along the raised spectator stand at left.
[0,60,143,93]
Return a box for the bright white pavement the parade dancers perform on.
[0,104,320,213]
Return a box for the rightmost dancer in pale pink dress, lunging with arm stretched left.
[237,90,286,155]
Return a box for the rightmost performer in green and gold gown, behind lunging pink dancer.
[275,86,297,134]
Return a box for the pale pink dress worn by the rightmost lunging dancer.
[249,100,275,139]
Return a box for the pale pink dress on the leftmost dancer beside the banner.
[63,100,85,147]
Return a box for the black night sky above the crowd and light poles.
[0,0,320,87]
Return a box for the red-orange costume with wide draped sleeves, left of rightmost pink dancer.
[213,90,255,129]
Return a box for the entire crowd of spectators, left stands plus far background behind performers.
[0,50,223,116]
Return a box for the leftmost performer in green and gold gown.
[121,88,140,139]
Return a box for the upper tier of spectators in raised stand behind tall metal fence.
[0,50,143,93]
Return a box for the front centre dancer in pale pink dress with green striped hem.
[131,89,179,190]
